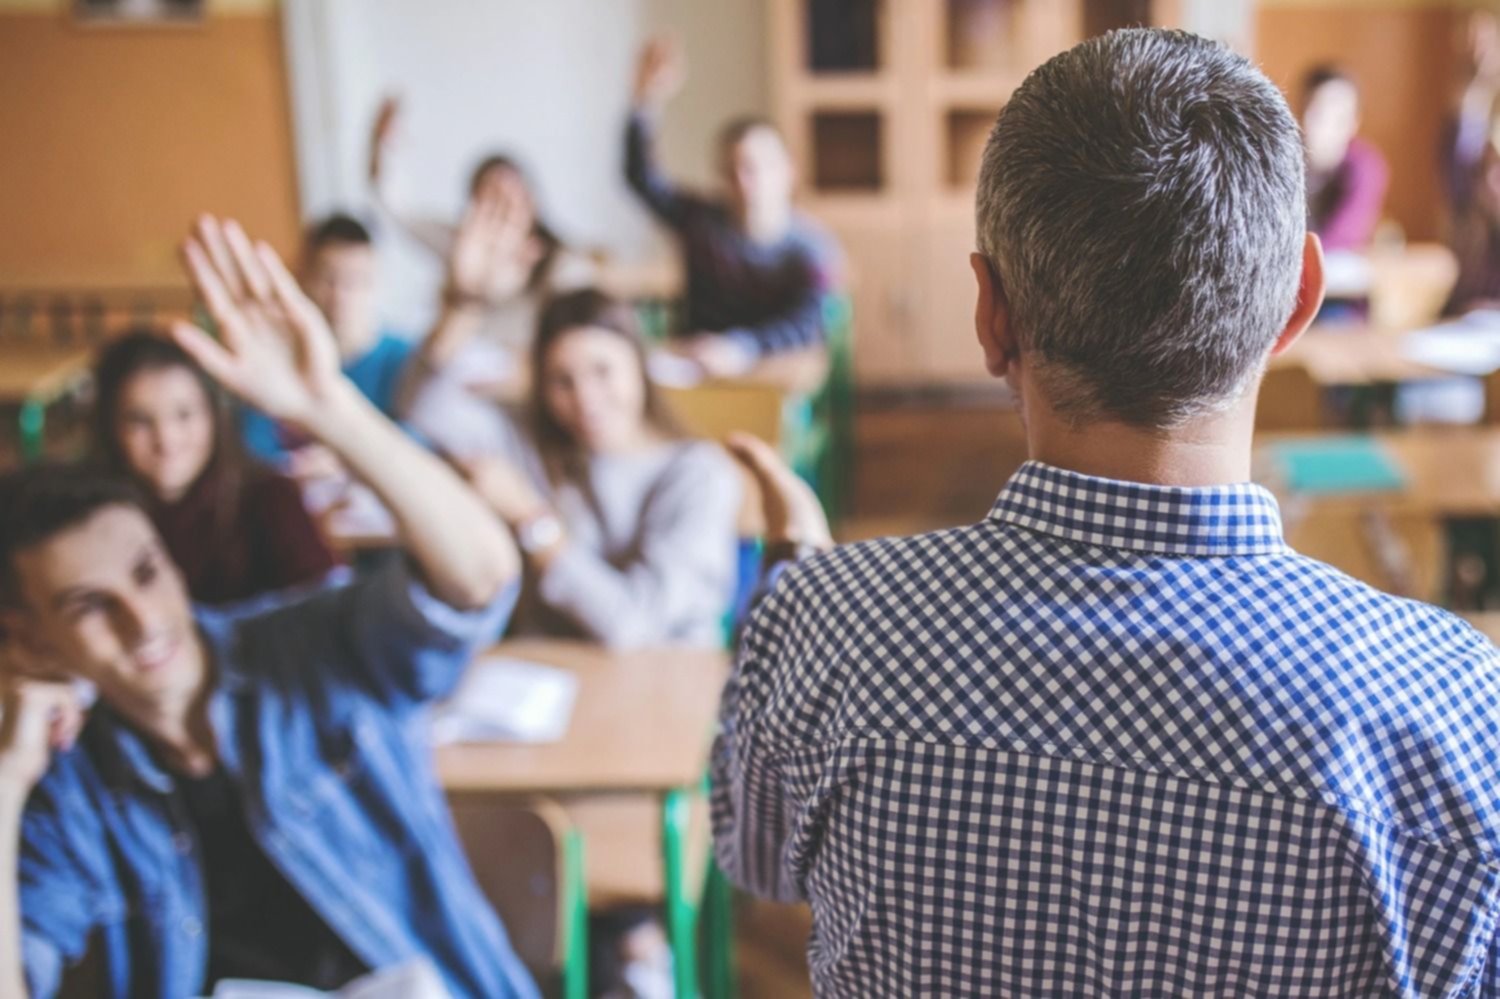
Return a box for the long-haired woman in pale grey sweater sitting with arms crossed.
[461,290,741,647]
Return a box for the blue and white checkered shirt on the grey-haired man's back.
[714,462,1500,998]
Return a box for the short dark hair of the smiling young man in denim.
[0,464,144,609]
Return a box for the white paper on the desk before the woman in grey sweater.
[432,657,578,744]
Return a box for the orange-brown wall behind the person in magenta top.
[1256,0,1481,240]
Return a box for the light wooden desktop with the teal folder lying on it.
[1256,426,1500,518]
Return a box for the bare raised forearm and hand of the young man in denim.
[173,216,521,609]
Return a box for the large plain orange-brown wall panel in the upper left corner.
[0,0,297,290]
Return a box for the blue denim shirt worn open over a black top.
[20,561,537,999]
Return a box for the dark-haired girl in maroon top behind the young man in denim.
[93,330,338,605]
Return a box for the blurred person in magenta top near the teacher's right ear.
[1301,65,1391,251]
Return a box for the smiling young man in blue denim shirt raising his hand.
[0,219,537,999]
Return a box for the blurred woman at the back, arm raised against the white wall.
[369,99,596,405]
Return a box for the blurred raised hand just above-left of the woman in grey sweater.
[447,189,542,305]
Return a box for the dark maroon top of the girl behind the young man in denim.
[150,471,339,605]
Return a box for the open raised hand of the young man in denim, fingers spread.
[173,215,345,428]
